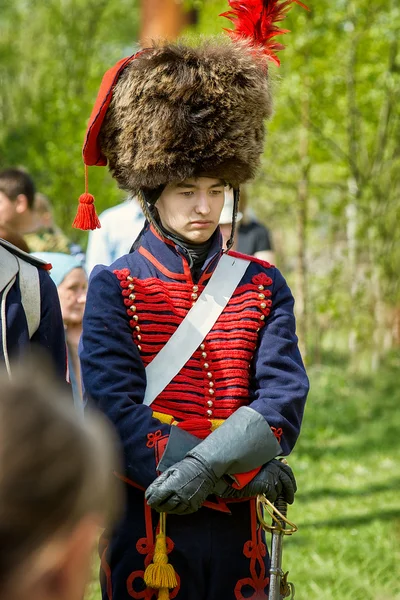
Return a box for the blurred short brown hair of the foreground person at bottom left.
[0,357,121,597]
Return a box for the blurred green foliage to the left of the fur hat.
[0,0,138,244]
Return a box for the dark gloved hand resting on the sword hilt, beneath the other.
[213,459,297,504]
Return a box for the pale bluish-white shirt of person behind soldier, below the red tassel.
[86,197,145,274]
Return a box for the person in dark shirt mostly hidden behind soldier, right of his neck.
[237,187,275,264]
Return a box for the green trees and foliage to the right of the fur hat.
[193,0,400,360]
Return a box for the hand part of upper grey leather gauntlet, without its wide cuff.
[145,456,218,515]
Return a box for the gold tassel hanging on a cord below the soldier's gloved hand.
[144,513,178,600]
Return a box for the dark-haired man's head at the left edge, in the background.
[0,169,35,232]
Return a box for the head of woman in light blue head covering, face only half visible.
[33,252,88,327]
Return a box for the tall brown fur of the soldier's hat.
[99,39,272,194]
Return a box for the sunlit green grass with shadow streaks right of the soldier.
[86,356,400,600]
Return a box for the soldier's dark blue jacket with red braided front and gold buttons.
[81,223,308,488]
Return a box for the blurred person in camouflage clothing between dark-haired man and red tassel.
[24,192,85,261]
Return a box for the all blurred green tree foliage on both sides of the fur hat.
[0,0,400,360]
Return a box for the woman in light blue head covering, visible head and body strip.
[34,252,87,414]
